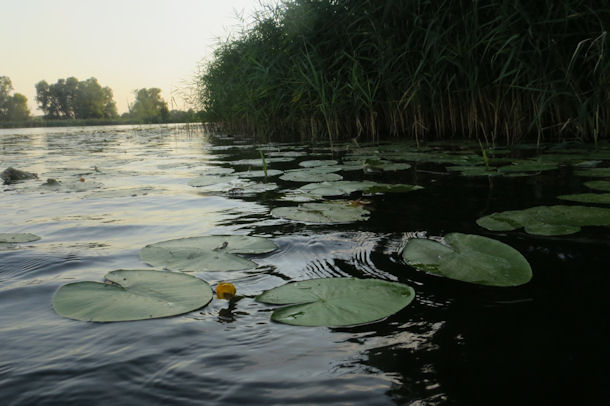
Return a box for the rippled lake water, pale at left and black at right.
[0,127,610,405]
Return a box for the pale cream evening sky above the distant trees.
[0,0,261,115]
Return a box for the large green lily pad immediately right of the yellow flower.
[256,278,415,327]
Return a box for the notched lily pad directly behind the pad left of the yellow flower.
[140,235,277,272]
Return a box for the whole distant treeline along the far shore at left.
[0,76,200,127]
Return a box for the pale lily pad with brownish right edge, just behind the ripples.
[271,200,370,224]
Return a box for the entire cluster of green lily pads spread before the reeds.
[28,140,610,327]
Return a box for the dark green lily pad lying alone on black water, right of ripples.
[402,233,532,286]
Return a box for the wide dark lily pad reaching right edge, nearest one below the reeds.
[477,205,610,235]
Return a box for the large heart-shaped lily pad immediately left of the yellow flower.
[53,270,213,322]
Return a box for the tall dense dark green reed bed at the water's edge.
[199,0,610,143]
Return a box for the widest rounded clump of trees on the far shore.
[36,77,118,119]
